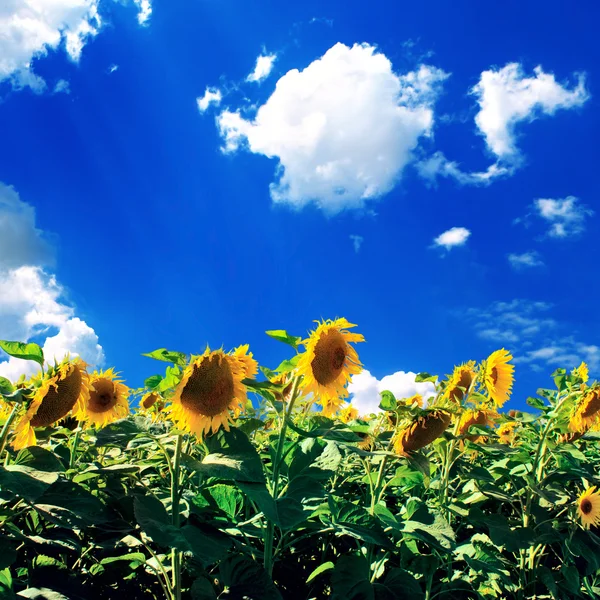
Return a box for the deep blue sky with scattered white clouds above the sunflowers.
[0,0,600,407]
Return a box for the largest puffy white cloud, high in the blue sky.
[217,43,448,214]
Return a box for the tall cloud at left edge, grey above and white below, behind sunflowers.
[0,183,104,380]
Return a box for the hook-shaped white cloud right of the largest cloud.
[471,63,590,161]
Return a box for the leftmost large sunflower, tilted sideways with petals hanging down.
[12,357,89,450]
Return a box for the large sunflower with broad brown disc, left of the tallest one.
[170,348,247,436]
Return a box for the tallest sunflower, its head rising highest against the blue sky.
[297,319,365,416]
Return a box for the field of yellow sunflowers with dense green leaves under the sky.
[0,319,600,600]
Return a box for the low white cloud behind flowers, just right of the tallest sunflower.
[348,370,435,416]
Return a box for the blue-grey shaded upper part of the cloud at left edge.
[0,182,54,271]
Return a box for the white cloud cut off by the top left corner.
[0,0,152,93]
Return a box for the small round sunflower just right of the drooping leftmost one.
[75,369,131,427]
